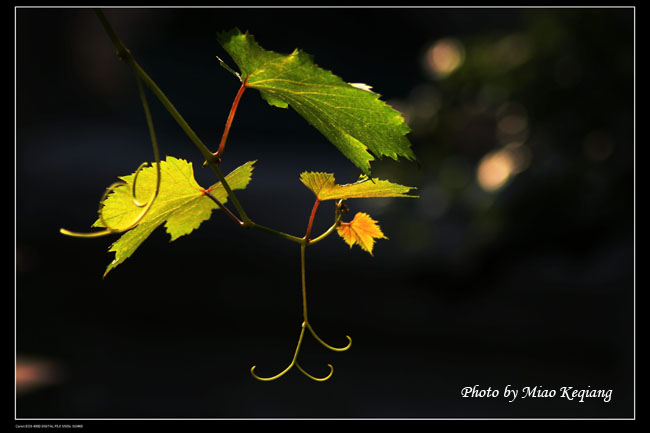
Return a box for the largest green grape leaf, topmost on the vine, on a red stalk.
[217,29,415,175]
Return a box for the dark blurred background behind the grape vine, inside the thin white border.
[15,8,635,419]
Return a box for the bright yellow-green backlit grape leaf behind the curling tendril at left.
[93,156,255,276]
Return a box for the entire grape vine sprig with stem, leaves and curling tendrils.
[60,9,416,381]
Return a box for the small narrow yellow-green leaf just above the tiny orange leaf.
[300,171,417,201]
